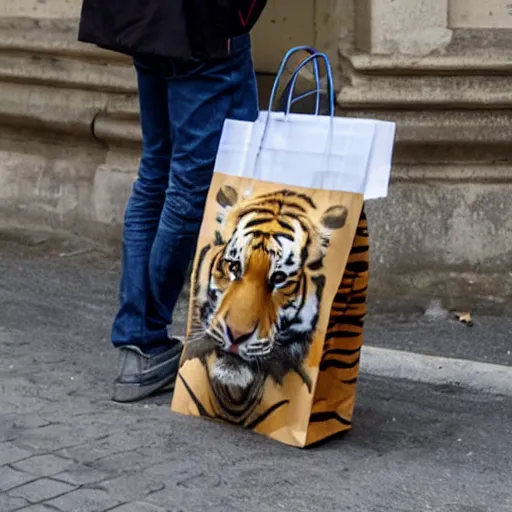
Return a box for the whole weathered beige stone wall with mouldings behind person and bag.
[0,0,512,305]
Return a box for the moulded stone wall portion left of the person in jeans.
[0,0,140,235]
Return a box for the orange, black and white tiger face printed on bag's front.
[192,186,347,387]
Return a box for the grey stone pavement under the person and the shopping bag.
[0,235,512,512]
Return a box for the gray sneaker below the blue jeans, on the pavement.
[112,339,183,402]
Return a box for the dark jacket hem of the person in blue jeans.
[78,0,267,60]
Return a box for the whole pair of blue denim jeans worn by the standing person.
[112,36,258,352]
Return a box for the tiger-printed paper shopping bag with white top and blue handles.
[172,48,395,447]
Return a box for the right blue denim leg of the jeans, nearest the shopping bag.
[149,36,258,332]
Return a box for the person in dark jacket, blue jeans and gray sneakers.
[78,0,266,402]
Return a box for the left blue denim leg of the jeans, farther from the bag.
[112,63,171,348]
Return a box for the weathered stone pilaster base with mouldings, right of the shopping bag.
[338,0,512,307]
